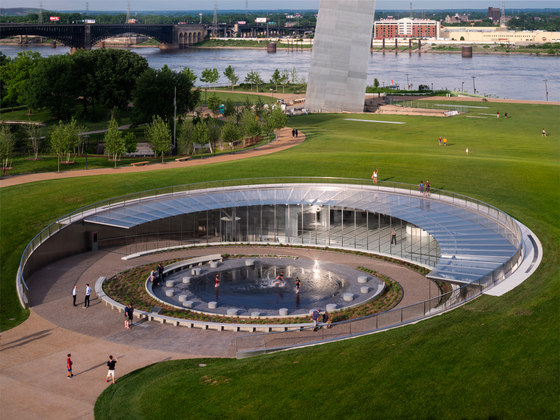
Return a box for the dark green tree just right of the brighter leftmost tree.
[23,55,79,118]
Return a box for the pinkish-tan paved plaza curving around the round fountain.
[0,247,435,420]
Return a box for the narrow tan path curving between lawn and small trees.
[0,127,305,188]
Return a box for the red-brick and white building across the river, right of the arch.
[374,18,440,39]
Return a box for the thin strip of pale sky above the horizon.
[10,0,560,11]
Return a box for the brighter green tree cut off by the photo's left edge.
[0,51,42,104]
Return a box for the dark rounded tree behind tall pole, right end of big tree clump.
[132,66,200,124]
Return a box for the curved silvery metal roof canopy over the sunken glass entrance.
[85,184,517,283]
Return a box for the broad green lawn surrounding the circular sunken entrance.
[0,103,560,419]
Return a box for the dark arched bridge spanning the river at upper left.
[0,23,208,50]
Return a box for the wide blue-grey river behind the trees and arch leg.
[0,45,560,102]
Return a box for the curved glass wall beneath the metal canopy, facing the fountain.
[121,204,440,266]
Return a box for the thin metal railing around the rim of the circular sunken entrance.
[16,177,522,338]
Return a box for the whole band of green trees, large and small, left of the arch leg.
[0,49,288,170]
